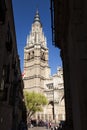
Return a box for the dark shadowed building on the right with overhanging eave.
[50,0,87,130]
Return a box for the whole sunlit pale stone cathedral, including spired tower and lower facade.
[23,10,65,122]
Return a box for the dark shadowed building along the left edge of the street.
[0,0,26,130]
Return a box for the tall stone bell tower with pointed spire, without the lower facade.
[24,10,50,92]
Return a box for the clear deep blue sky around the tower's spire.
[12,0,62,74]
